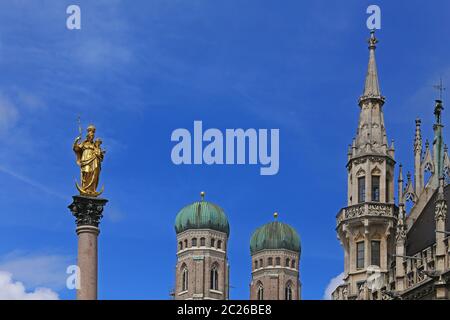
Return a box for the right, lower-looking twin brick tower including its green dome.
[250,213,301,300]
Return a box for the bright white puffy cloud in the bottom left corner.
[0,271,59,300]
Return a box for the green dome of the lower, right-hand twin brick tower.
[250,213,301,255]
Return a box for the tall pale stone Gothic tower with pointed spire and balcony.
[336,31,398,299]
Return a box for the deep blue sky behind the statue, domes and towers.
[0,0,450,299]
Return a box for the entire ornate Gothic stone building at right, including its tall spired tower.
[332,32,450,300]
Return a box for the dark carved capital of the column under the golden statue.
[68,196,108,228]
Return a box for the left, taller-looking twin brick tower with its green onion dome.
[173,192,230,300]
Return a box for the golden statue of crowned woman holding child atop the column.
[73,125,106,197]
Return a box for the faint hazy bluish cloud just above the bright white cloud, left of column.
[0,252,74,290]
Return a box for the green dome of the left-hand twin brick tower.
[175,192,230,236]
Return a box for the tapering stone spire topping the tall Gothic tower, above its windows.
[356,31,393,157]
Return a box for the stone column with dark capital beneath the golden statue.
[69,196,108,300]
